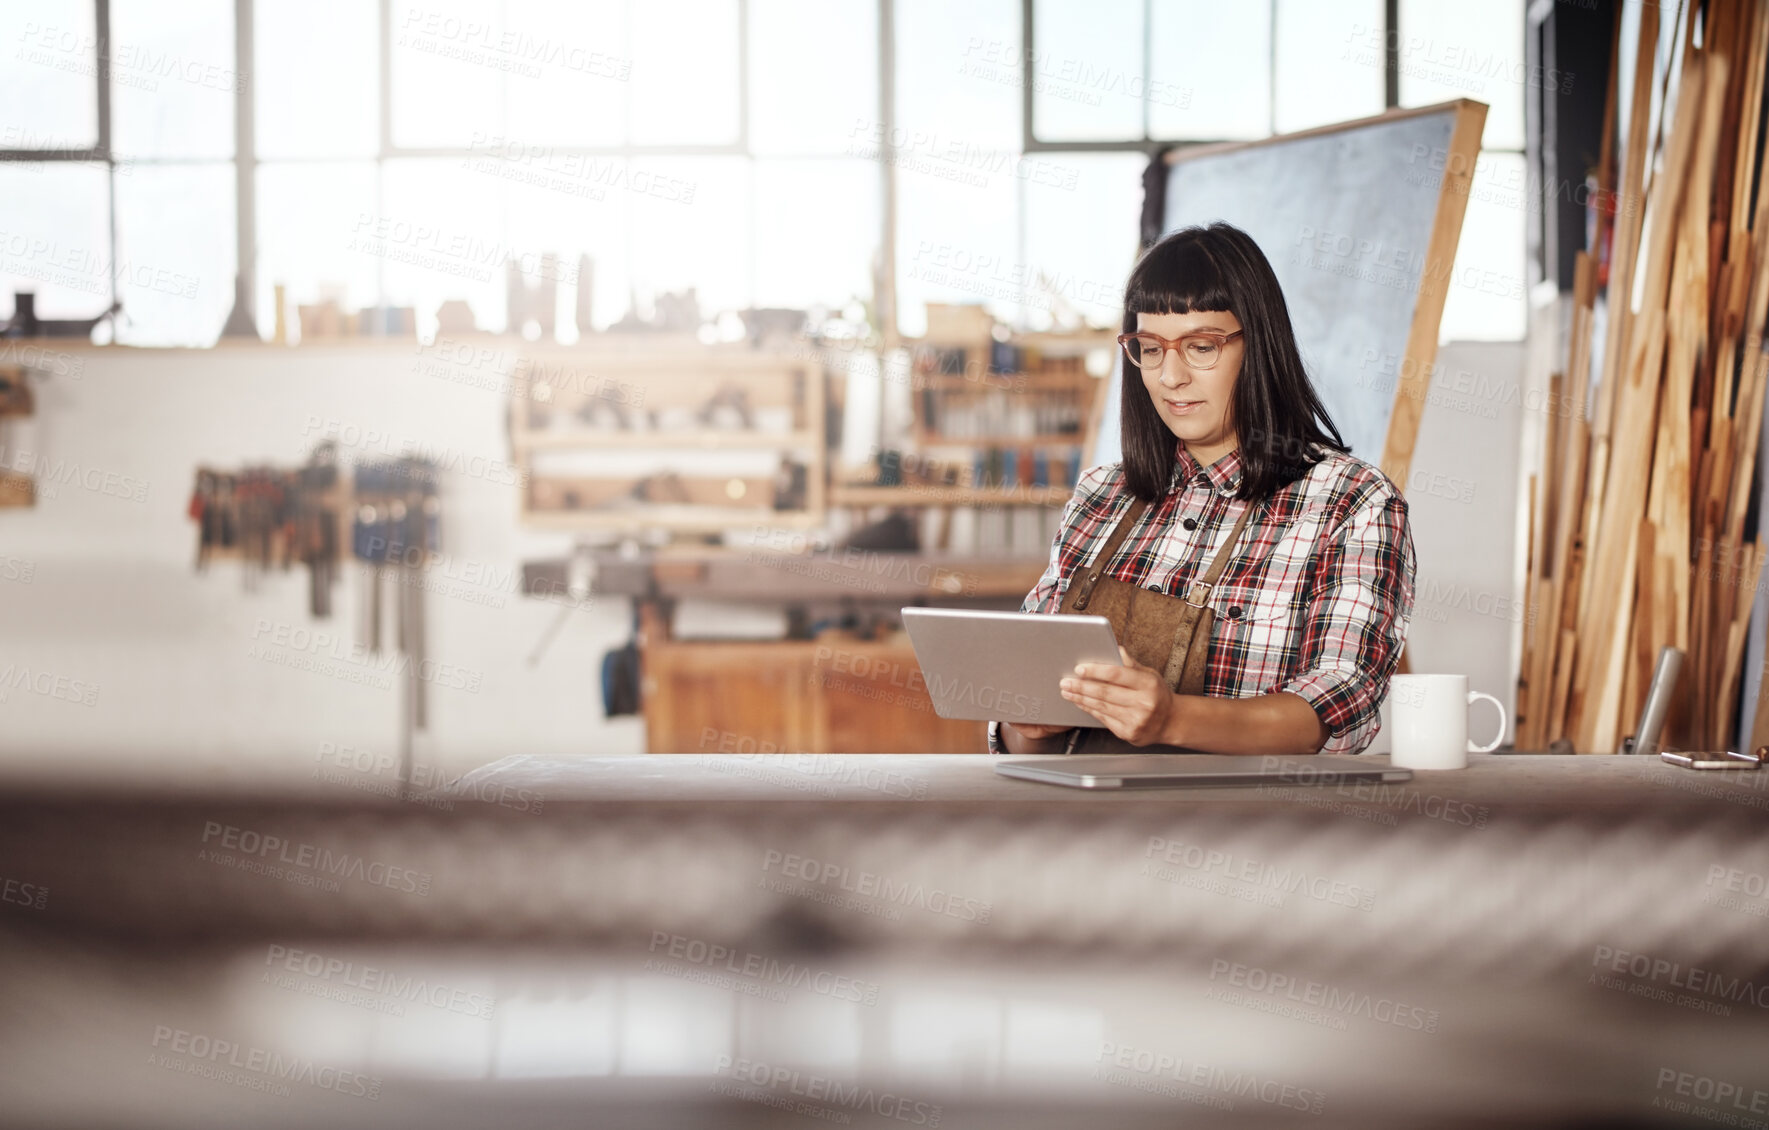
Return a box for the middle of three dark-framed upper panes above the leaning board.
[1148,0,1272,138]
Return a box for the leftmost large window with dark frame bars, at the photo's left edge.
[0,0,244,343]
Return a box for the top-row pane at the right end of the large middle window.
[750,0,879,154]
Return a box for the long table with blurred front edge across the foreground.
[0,755,1769,1126]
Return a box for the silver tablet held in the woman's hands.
[902,608,1122,727]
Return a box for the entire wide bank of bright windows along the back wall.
[0,0,1527,345]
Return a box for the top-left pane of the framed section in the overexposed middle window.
[389,0,505,149]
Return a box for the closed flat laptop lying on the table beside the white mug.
[996,753,1413,789]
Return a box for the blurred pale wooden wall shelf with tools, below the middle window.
[509,338,828,532]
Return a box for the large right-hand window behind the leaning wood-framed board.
[1018,0,1530,340]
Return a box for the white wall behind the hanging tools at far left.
[0,343,642,778]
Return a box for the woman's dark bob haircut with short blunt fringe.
[1118,223,1346,500]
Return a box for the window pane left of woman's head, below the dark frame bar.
[1024,154,1148,329]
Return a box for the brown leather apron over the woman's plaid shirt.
[1058,499,1256,753]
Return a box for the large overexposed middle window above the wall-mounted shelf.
[257,0,881,340]
